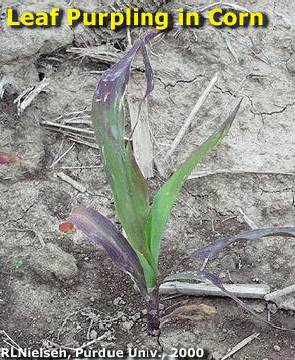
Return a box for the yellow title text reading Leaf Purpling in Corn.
[7,7,268,30]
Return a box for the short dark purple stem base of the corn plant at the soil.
[147,286,160,336]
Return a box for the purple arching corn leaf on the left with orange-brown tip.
[60,206,146,295]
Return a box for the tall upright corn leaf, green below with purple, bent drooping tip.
[92,30,162,282]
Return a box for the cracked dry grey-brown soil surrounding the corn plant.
[0,1,295,360]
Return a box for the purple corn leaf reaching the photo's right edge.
[190,227,295,260]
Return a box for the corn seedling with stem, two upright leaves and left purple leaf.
[60,31,241,334]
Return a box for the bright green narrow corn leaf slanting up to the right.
[146,99,242,264]
